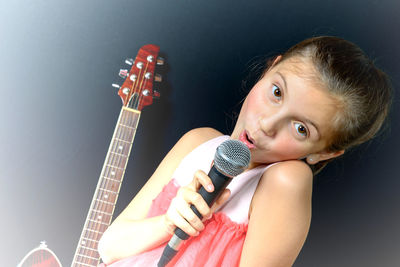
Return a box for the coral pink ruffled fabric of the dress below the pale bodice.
[111,179,248,267]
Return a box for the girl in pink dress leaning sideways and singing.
[99,37,391,267]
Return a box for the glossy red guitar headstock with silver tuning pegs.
[113,44,164,110]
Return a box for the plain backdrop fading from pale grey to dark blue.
[0,0,400,267]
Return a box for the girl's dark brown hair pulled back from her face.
[267,36,392,173]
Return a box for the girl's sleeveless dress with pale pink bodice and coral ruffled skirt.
[110,136,271,267]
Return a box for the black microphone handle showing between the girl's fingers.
[174,165,232,240]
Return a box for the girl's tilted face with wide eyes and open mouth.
[232,58,337,169]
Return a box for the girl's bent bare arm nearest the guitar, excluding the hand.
[98,128,221,264]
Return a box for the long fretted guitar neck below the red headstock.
[71,107,140,267]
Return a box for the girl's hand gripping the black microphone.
[165,170,230,236]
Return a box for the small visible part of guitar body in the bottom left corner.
[17,242,62,267]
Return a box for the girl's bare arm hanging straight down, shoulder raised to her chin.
[240,161,313,267]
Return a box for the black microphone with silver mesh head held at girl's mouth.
[157,139,250,267]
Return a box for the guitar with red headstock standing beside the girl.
[18,44,164,267]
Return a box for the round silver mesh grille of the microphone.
[214,139,250,177]
